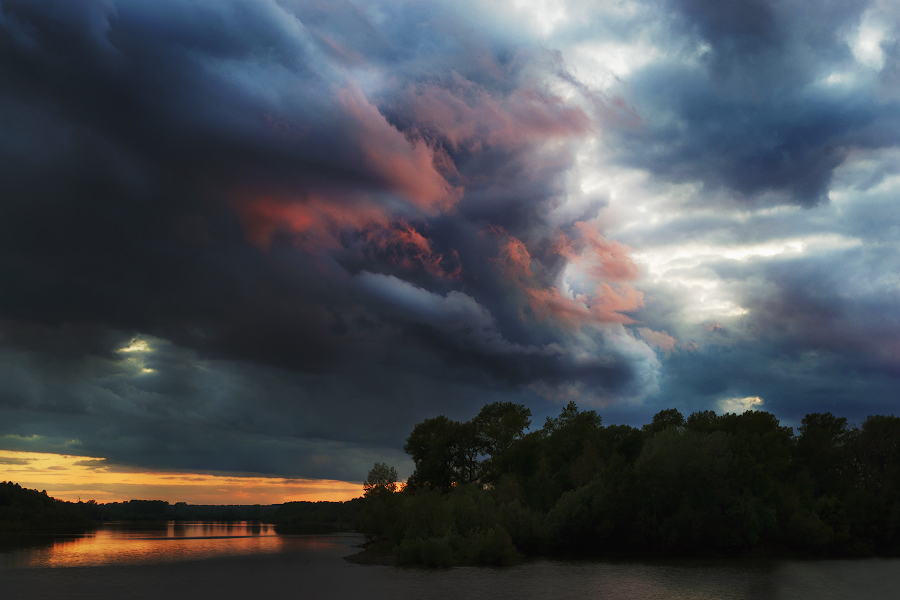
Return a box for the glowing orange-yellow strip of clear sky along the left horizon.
[0,450,363,504]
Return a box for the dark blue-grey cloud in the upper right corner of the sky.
[623,0,900,206]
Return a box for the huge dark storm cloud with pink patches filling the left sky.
[0,1,655,479]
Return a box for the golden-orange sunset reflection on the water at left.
[11,521,337,568]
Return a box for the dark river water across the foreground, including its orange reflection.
[0,523,900,600]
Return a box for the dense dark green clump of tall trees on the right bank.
[360,403,900,565]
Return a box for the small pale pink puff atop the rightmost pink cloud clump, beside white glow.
[557,221,640,281]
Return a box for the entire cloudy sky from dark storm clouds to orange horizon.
[0,0,900,503]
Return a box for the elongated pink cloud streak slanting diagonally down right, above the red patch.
[337,85,462,214]
